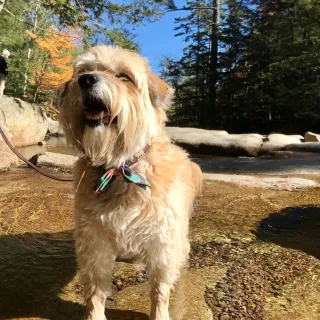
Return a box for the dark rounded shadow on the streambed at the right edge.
[255,206,320,259]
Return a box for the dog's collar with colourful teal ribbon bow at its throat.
[93,145,151,198]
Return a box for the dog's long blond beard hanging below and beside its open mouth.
[82,92,159,167]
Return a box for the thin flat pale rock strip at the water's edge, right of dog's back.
[203,173,319,191]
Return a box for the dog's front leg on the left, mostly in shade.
[76,228,115,320]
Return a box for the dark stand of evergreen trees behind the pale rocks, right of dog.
[165,0,320,133]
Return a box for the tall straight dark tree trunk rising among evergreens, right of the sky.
[204,0,220,128]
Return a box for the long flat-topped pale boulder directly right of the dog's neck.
[166,127,263,156]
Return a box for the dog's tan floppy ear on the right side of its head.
[148,70,174,110]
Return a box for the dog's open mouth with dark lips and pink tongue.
[83,99,111,127]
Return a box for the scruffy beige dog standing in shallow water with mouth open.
[60,46,201,320]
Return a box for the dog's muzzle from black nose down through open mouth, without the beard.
[78,73,111,127]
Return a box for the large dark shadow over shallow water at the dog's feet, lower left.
[0,231,148,320]
